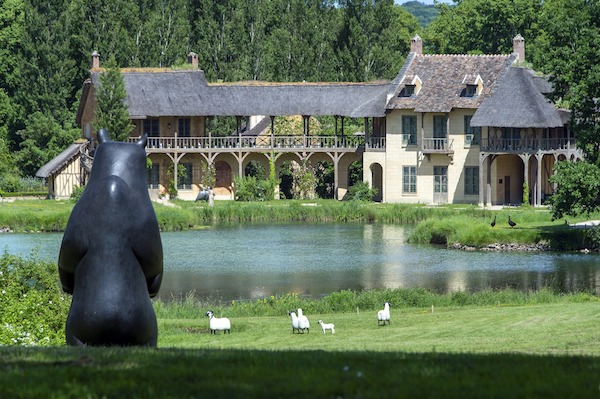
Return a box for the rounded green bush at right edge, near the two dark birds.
[550,162,600,219]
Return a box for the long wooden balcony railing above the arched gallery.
[129,136,370,151]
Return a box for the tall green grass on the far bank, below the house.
[0,199,600,250]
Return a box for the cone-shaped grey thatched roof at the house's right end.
[471,67,564,128]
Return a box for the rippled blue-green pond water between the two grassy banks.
[0,223,600,301]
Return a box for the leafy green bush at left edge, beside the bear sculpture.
[0,253,70,346]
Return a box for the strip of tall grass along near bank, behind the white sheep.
[155,287,600,319]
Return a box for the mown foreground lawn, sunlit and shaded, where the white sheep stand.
[0,302,600,398]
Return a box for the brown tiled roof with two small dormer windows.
[387,53,516,112]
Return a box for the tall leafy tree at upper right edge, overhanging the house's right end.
[535,0,600,163]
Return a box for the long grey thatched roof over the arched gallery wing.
[86,69,390,119]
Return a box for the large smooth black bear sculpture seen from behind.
[58,129,163,346]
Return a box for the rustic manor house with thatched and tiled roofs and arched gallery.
[38,35,581,206]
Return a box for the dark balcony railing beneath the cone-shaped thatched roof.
[480,138,577,152]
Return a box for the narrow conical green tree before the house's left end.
[94,56,133,141]
